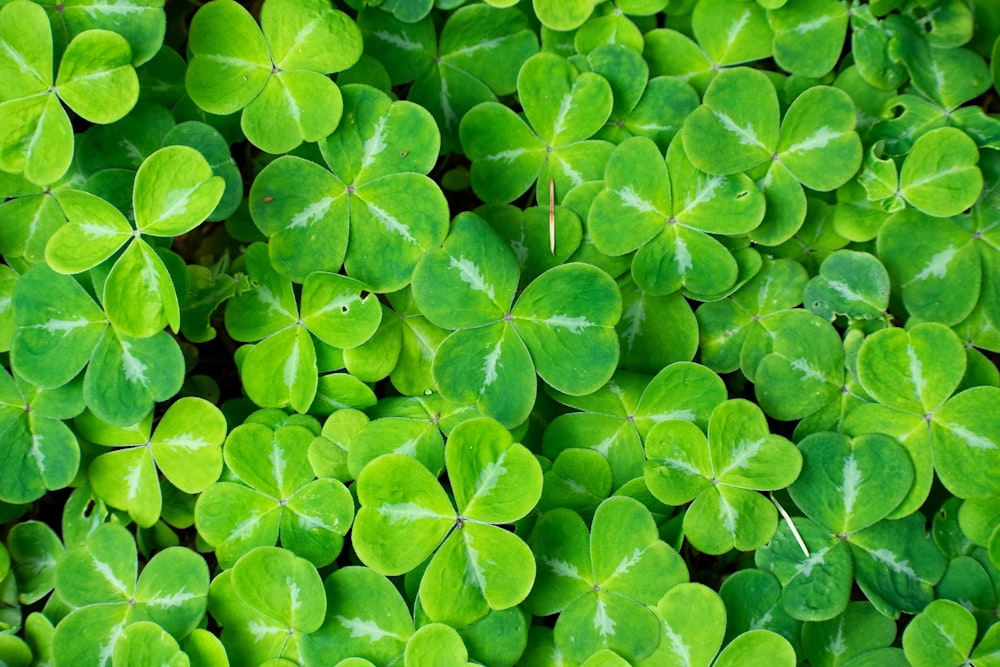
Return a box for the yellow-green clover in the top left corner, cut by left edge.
[0,0,139,185]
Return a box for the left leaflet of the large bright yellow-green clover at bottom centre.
[352,454,456,576]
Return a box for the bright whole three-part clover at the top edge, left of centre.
[185,0,361,153]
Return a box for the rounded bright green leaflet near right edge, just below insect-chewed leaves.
[899,127,983,218]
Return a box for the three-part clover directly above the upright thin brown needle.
[459,52,613,203]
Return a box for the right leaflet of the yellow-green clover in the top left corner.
[55,30,139,124]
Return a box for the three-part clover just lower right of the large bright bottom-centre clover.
[527,496,688,662]
